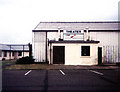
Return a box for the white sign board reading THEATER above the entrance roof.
[63,30,84,40]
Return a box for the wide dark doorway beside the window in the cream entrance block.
[53,46,65,64]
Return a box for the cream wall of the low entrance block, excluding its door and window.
[50,43,98,65]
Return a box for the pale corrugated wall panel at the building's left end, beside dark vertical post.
[33,32,47,62]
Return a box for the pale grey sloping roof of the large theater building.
[34,21,120,31]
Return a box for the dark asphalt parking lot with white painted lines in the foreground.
[2,69,120,92]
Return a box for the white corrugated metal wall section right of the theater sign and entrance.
[90,32,120,63]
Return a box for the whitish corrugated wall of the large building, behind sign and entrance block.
[33,30,120,63]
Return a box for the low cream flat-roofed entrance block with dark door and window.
[49,41,99,65]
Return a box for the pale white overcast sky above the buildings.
[0,0,120,44]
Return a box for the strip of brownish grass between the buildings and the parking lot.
[0,61,120,70]
